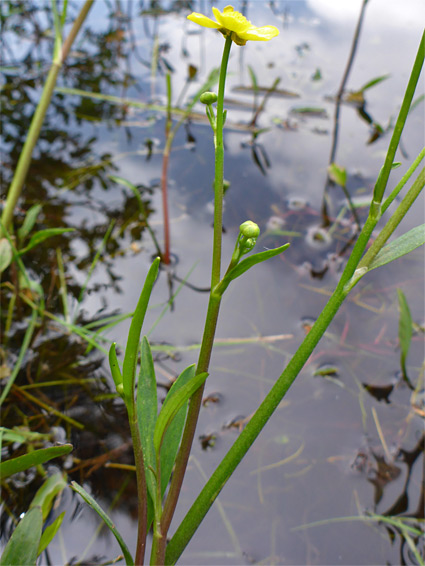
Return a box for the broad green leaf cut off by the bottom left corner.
[0,507,43,566]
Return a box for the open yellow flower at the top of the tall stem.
[187,6,279,45]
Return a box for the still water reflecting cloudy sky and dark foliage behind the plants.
[2,0,425,565]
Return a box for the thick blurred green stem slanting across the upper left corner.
[0,0,94,235]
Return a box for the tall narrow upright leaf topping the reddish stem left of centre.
[122,257,161,402]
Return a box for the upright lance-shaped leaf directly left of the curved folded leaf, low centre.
[136,336,158,510]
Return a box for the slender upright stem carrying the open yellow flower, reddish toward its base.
[161,38,232,560]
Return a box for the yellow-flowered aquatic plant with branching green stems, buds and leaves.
[3,7,425,565]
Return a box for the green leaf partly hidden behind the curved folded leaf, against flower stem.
[161,364,195,494]
